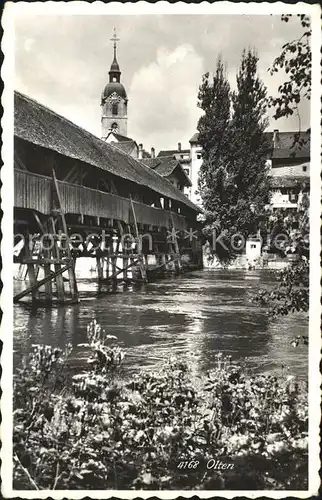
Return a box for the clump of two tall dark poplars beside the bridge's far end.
[197,51,269,260]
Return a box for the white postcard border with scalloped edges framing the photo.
[1,1,321,499]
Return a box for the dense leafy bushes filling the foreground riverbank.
[13,324,308,490]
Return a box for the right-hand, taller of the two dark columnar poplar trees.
[230,50,269,232]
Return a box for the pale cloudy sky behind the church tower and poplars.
[15,14,310,152]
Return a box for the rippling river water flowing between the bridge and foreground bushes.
[14,270,308,379]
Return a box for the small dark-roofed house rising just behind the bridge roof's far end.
[141,155,191,192]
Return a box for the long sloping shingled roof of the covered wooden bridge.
[14,91,200,212]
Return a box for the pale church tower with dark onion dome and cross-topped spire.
[101,28,128,140]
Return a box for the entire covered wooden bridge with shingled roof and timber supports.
[14,92,201,302]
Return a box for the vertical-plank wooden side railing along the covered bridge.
[14,170,188,230]
